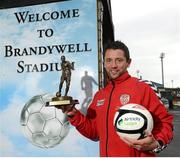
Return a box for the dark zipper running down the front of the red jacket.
[106,81,115,157]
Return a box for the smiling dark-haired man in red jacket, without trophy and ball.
[57,41,173,157]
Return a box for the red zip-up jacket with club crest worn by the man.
[69,72,173,157]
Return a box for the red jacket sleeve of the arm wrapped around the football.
[143,85,173,145]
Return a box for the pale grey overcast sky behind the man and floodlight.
[111,0,180,87]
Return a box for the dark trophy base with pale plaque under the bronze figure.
[46,96,79,106]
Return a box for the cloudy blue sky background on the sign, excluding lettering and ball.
[0,0,99,157]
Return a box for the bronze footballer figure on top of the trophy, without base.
[56,55,74,96]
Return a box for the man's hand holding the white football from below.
[121,132,159,151]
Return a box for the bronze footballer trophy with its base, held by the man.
[46,55,79,107]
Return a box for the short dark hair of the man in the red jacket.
[104,41,130,61]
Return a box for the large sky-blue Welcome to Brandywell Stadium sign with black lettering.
[0,0,99,157]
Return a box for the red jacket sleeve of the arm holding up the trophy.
[69,92,99,141]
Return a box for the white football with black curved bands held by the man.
[114,104,153,139]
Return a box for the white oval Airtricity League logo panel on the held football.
[117,113,144,130]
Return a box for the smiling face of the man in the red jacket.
[104,49,131,79]
